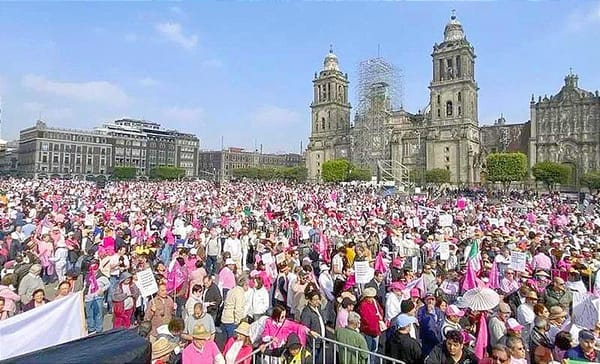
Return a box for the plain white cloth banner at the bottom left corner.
[0,292,87,360]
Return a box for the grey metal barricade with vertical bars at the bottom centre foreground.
[235,337,405,364]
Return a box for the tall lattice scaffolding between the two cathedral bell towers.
[352,57,403,174]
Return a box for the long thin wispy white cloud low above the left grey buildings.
[22,74,130,106]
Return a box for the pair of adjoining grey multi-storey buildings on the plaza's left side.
[18,119,200,178]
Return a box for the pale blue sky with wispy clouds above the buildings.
[0,1,600,152]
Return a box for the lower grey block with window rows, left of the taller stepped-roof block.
[18,121,113,177]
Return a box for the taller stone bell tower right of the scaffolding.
[426,11,479,184]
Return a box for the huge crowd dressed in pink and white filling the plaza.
[0,179,600,364]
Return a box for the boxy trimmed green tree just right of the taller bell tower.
[486,153,527,189]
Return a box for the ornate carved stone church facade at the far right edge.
[529,73,600,184]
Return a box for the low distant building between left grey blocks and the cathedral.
[198,148,305,180]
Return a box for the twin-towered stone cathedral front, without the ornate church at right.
[307,15,481,184]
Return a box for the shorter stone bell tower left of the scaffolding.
[306,48,351,181]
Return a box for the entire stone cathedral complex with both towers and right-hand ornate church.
[306,14,600,185]
